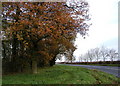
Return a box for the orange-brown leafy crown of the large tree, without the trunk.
[2,2,90,64]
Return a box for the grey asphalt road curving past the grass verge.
[63,64,120,78]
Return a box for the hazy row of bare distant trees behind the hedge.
[79,46,118,62]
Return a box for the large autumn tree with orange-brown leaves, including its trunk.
[2,2,89,73]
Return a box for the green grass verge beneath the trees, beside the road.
[2,65,118,84]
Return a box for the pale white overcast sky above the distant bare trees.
[74,0,120,61]
